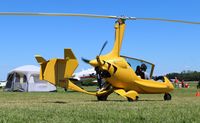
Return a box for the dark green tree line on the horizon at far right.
[166,70,200,81]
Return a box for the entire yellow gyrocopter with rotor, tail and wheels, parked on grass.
[0,12,200,101]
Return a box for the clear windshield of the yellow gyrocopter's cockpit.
[121,56,155,78]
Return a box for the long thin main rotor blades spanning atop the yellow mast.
[0,12,200,24]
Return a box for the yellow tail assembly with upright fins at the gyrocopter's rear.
[36,49,78,88]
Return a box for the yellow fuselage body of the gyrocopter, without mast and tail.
[91,57,174,94]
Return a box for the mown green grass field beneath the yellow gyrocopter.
[0,81,200,123]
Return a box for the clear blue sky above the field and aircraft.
[0,0,200,80]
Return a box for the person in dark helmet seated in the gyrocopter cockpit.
[135,64,150,79]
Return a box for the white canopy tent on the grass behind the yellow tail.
[5,65,56,92]
